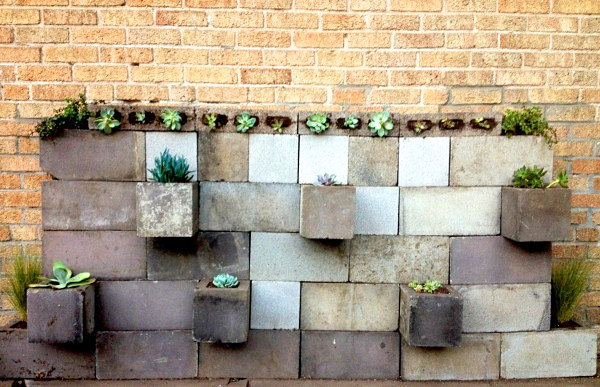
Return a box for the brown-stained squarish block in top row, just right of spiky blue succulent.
[198,133,249,181]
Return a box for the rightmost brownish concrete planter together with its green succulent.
[501,166,571,242]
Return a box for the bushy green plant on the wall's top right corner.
[502,106,558,146]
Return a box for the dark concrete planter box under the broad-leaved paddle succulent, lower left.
[27,284,95,344]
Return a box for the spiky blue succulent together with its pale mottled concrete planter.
[136,149,198,238]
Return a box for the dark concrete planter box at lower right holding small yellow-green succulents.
[400,285,463,347]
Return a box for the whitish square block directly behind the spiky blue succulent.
[146,132,198,181]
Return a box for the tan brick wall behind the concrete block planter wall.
[0,0,600,323]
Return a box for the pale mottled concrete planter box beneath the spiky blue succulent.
[136,183,198,238]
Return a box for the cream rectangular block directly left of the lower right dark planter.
[300,283,400,331]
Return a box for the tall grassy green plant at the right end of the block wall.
[552,260,591,324]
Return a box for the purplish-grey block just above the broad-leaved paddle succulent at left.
[42,231,146,280]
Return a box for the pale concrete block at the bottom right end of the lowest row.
[500,329,597,379]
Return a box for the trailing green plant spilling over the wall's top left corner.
[35,94,90,138]
